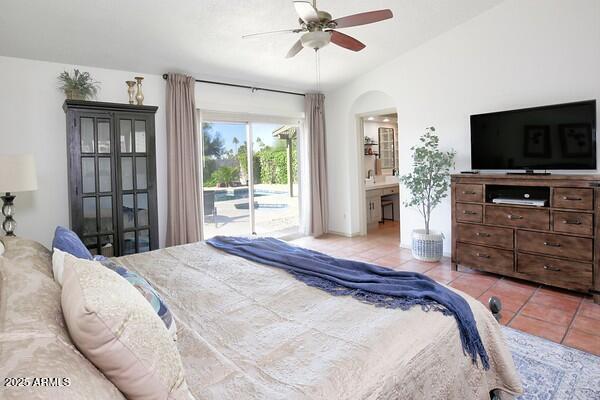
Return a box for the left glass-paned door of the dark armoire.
[79,115,118,257]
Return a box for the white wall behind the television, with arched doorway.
[326,0,600,250]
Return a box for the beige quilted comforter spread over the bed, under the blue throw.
[119,243,522,400]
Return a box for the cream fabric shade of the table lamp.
[0,154,37,193]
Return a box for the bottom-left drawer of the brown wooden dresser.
[456,243,513,274]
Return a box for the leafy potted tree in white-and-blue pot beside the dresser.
[400,126,456,262]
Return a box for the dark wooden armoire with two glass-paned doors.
[63,100,158,257]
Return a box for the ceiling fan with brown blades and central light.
[242,0,394,58]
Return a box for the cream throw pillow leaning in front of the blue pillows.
[61,254,193,400]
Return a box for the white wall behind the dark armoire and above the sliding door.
[0,57,304,246]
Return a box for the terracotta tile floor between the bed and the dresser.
[292,221,600,355]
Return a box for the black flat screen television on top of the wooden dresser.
[471,100,596,171]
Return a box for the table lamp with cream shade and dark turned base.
[0,154,37,236]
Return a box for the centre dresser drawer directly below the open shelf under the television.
[485,206,550,230]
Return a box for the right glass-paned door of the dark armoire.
[116,114,150,255]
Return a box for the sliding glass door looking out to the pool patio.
[202,120,299,239]
